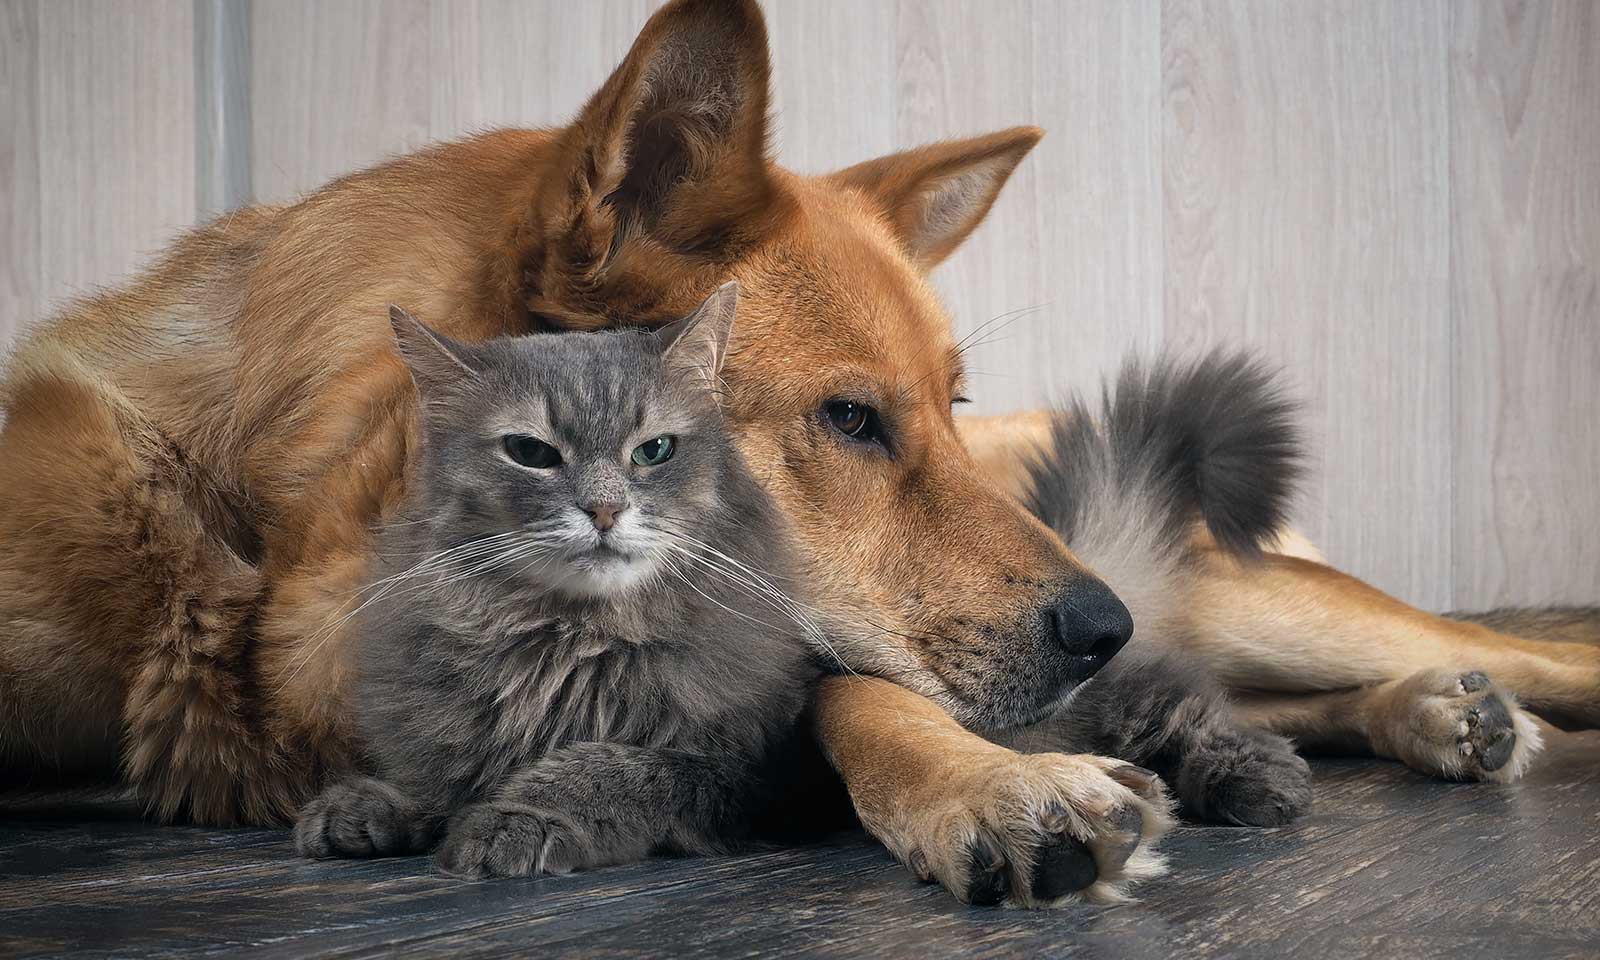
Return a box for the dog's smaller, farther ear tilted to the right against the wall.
[830,126,1045,270]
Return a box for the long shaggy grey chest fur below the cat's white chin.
[358,547,806,810]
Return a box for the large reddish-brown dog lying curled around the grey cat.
[0,0,1600,902]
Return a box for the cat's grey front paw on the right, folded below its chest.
[435,803,590,878]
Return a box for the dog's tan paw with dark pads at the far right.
[1373,670,1544,782]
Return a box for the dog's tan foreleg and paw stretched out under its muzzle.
[816,677,1171,906]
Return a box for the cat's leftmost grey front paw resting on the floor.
[294,778,429,859]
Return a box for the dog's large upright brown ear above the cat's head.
[522,0,781,326]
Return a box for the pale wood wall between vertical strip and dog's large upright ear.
[251,0,654,200]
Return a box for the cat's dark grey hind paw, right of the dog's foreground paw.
[1174,731,1312,827]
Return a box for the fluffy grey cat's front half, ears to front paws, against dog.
[294,283,816,877]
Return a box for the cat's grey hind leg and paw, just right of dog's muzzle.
[1000,642,1312,827]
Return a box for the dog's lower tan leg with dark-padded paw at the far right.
[1235,670,1544,782]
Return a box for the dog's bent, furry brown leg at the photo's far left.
[0,358,296,824]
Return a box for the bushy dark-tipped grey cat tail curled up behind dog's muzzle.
[1027,352,1301,590]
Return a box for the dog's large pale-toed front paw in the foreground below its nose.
[867,750,1171,906]
